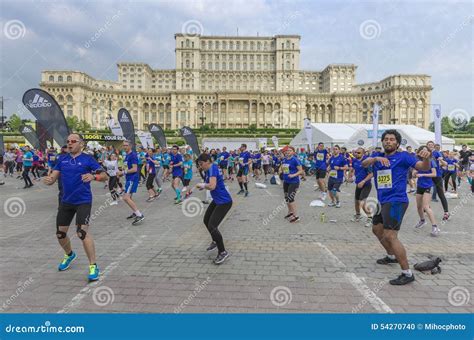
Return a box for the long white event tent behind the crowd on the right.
[290,123,455,150]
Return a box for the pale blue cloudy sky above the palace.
[0,0,474,122]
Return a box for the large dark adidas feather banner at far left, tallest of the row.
[23,89,70,145]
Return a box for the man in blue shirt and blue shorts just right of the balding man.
[117,140,145,225]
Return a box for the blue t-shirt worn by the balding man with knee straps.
[54,153,103,205]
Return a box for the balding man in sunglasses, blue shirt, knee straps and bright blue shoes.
[44,133,107,281]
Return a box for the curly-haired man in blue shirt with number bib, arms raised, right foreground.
[362,130,431,285]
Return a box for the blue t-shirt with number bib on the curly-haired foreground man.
[373,151,418,204]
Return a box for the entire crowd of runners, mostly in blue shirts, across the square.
[1,130,474,285]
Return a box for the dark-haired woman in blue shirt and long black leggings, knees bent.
[196,153,232,264]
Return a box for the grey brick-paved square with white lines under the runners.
[0,178,474,313]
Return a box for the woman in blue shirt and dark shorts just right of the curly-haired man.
[415,146,439,236]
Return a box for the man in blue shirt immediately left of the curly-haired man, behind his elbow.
[350,147,374,227]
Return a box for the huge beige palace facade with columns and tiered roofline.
[40,34,432,129]
